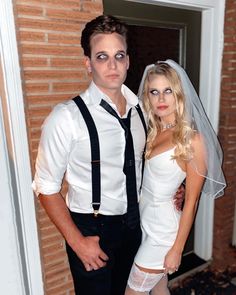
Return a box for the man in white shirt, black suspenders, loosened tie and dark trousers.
[33,15,182,295]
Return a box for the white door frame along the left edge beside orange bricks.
[0,0,44,295]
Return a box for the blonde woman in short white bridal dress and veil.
[125,60,225,295]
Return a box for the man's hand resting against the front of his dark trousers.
[74,236,108,271]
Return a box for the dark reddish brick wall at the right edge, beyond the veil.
[213,0,236,269]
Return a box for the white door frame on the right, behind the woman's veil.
[126,0,225,260]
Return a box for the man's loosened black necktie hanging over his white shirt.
[100,99,139,229]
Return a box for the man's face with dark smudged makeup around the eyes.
[86,33,129,94]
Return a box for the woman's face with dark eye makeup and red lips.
[148,75,176,123]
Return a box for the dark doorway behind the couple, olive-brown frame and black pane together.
[103,0,201,92]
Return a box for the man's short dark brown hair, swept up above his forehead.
[81,15,128,57]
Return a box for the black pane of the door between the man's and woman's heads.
[125,25,180,93]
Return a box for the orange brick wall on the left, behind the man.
[14,0,102,295]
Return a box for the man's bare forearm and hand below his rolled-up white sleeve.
[39,193,108,271]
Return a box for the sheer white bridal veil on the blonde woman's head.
[138,59,226,198]
